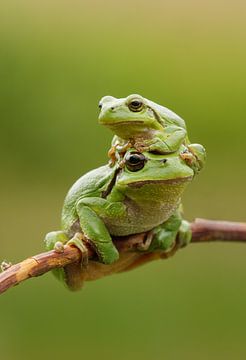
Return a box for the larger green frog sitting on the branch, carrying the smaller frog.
[45,146,194,286]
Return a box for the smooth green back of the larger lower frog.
[62,165,114,230]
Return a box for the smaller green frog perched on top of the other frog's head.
[99,94,206,172]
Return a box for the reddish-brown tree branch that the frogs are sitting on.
[0,219,246,294]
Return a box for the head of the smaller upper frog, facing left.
[99,94,164,140]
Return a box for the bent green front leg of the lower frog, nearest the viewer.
[76,197,125,264]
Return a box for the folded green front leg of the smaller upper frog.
[147,127,187,154]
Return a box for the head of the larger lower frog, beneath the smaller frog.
[117,149,194,188]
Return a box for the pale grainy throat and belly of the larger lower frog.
[103,181,187,236]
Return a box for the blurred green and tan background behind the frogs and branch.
[0,0,246,360]
